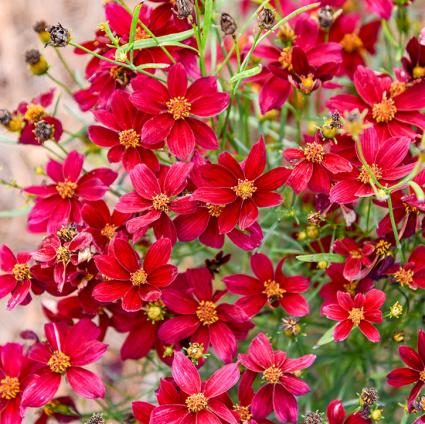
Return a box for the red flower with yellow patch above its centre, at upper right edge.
[327,66,425,140]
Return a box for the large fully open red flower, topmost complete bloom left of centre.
[130,63,229,159]
